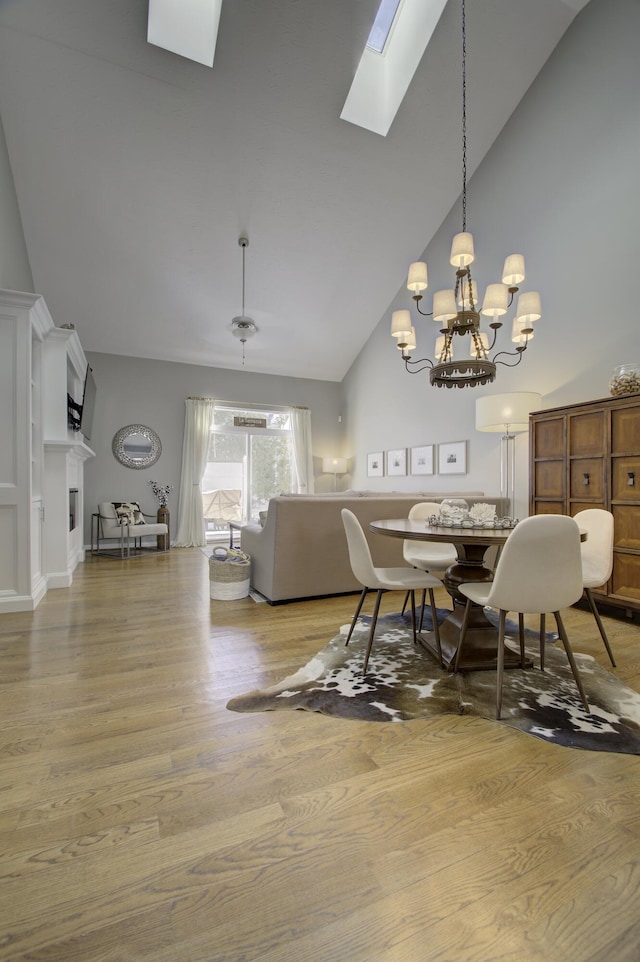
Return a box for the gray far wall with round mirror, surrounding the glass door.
[80,348,349,543]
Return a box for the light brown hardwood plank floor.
[0,548,640,962]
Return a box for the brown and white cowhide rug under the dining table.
[227,612,640,755]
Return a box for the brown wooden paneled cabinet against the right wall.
[529,394,640,611]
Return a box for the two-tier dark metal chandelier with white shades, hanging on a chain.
[391,0,541,387]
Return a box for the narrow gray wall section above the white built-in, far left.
[0,114,34,292]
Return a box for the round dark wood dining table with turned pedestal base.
[369,518,531,671]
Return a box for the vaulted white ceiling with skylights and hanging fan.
[0,0,586,381]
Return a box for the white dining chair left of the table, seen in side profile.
[341,508,442,672]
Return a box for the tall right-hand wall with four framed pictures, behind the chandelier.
[343,0,640,516]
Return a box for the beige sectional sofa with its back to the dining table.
[240,491,508,604]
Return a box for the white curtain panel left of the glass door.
[174,398,215,548]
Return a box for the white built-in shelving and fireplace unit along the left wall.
[0,291,93,613]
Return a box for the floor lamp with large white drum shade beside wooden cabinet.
[476,391,542,517]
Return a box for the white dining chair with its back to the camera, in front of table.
[455,514,590,718]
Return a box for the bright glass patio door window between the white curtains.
[202,402,293,538]
